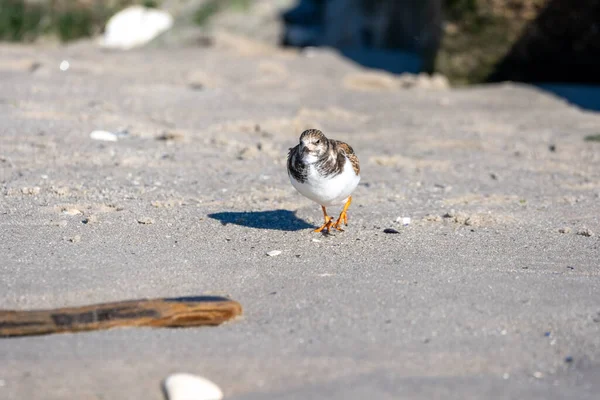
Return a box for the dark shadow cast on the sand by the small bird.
[208,210,315,232]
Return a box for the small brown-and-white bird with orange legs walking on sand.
[287,129,360,232]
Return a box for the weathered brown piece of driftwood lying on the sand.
[0,296,242,337]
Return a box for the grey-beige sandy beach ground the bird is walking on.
[0,41,600,400]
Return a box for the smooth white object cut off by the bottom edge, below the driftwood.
[163,373,223,400]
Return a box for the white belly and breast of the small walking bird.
[290,158,360,207]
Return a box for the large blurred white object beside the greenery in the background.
[100,6,173,50]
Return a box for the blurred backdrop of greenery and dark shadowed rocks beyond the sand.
[0,0,600,111]
